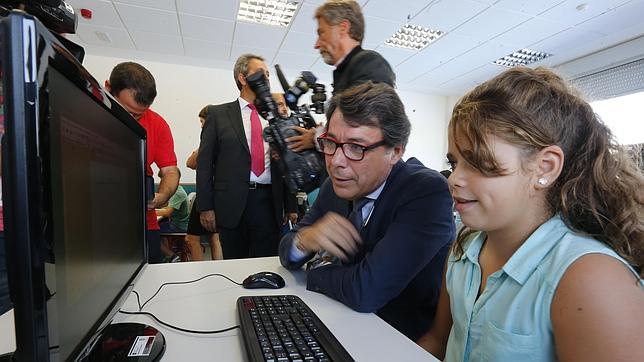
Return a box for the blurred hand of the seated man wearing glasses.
[298,212,362,260]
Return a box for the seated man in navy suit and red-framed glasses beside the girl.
[280,82,454,340]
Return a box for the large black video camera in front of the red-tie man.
[246,65,326,192]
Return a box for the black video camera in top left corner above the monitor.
[0,0,78,34]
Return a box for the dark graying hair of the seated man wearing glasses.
[326,81,411,149]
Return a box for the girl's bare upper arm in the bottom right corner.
[550,254,644,361]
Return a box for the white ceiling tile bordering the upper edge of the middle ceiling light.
[411,0,488,32]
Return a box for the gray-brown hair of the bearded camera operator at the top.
[315,0,364,44]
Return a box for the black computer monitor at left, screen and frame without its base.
[0,11,146,361]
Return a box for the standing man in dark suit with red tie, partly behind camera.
[197,54,296,259]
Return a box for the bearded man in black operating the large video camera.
[287,0,396,152]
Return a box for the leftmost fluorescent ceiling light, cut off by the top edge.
[237,0,299,27]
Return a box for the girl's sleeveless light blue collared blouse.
[445,216,644,362]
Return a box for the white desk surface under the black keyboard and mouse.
[115,257,437,361]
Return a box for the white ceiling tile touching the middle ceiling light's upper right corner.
[454,7,530,40]
